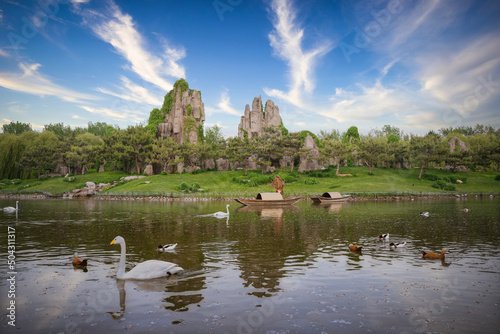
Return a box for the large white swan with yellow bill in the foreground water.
[110,236,184,280]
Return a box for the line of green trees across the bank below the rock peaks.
[0,122,500,179]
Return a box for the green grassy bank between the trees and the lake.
[0,167,500,198]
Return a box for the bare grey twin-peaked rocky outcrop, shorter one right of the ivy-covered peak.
[238,96,282,138]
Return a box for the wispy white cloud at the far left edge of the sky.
[0,63,97,103]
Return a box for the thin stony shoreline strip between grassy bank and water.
[0,194,500,204]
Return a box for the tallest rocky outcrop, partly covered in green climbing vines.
[156,79,205,144]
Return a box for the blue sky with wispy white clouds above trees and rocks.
[0,0,500,136]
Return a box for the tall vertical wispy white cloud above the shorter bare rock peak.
[264,0,332,106]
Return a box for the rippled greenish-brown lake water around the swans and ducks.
[0,198,500,333]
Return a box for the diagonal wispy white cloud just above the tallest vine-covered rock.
[87,2,186,92]
